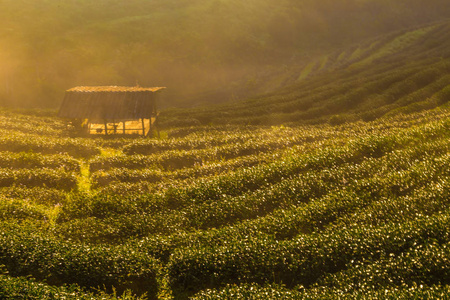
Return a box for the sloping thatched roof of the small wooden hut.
[58,86,164,120]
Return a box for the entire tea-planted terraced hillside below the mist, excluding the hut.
[0,23,450,299]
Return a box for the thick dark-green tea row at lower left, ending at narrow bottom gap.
[0,223,160,299]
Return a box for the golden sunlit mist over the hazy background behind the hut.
[0,0,450,109]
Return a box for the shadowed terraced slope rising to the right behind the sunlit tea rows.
[163,22,450,127]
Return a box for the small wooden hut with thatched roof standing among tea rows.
[58,86,164,136]
